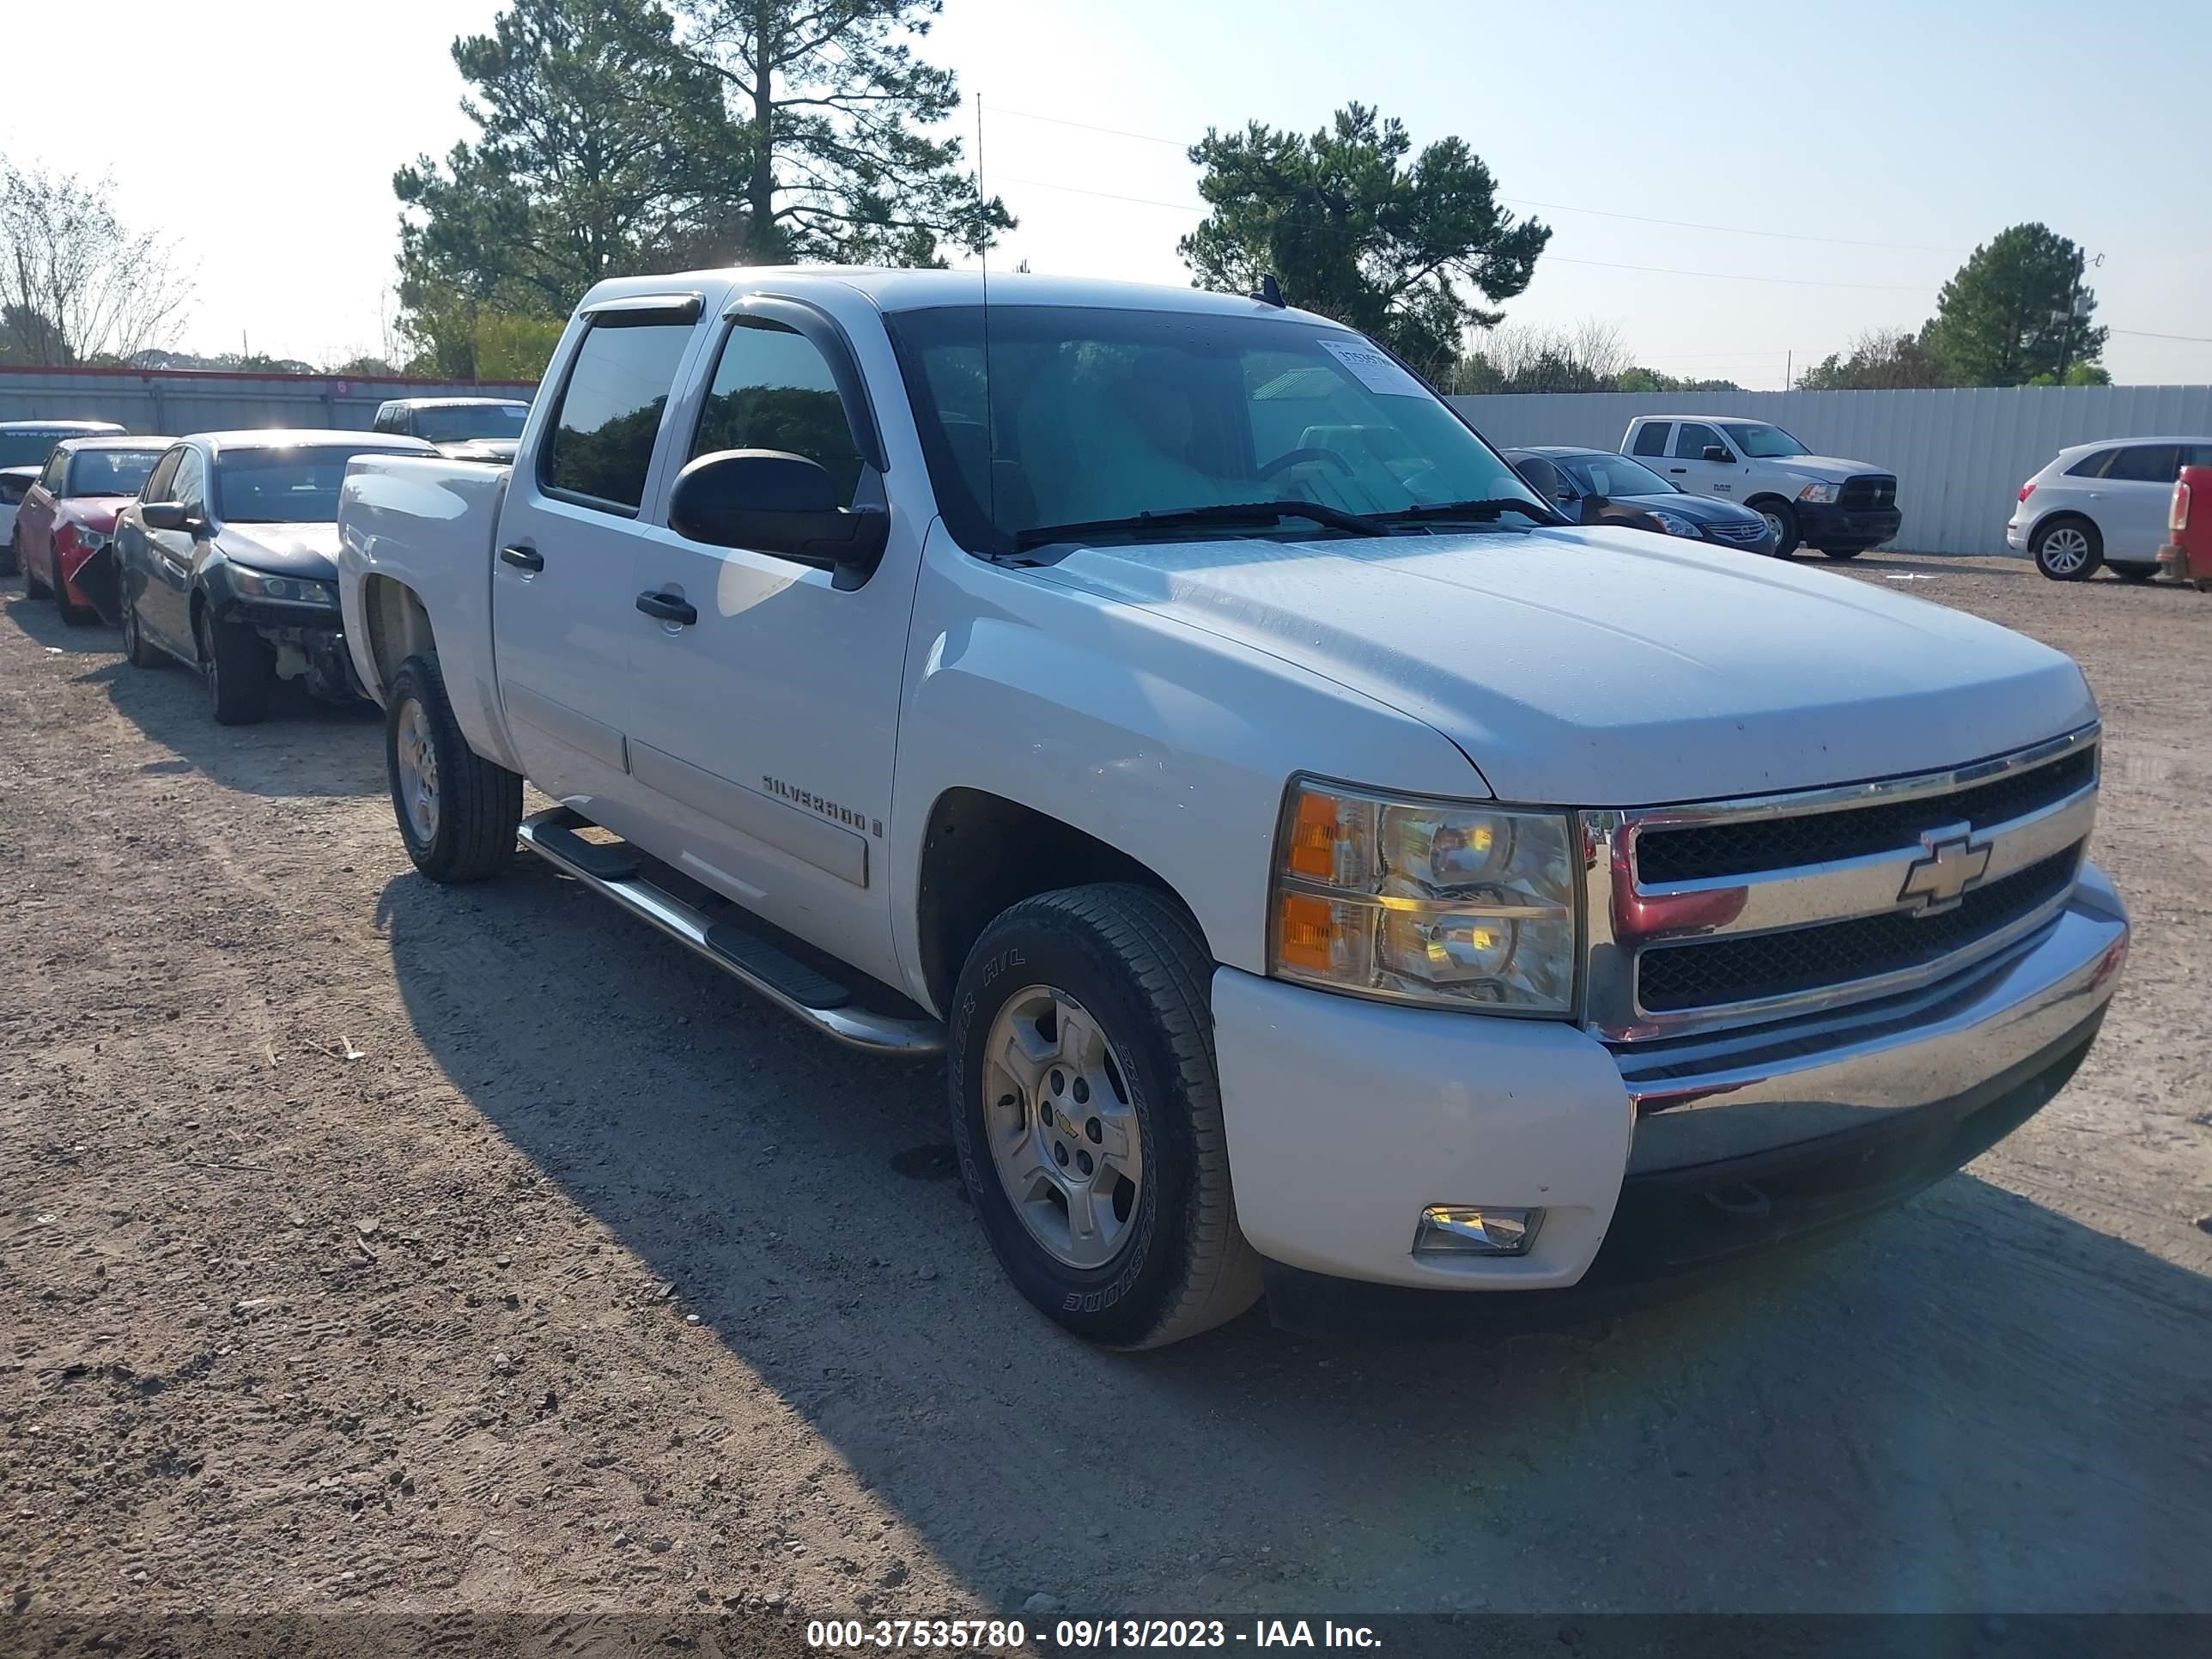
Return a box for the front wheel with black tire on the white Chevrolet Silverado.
[949,884,1261,1347]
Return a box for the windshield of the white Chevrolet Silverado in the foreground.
[887,305,1555,553]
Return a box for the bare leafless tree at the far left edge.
[0,161,192,365]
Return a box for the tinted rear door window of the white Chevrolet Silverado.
[538,312,692,518]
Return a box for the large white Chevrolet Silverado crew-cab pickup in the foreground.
[338,268,2128,1347]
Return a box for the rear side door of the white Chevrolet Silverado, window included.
[491,296,699,834]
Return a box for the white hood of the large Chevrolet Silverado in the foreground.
[1036,529,2097,807]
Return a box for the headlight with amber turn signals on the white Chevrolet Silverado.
[1267,779,1579,1015]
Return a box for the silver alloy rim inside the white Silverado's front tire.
[982,984,1144,1267]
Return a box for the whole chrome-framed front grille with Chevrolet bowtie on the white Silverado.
[1583,728,2097,1042]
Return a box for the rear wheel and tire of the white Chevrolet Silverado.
[385,657,522,883]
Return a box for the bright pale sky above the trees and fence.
[0,0,2212,387]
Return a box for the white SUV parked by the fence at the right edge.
[2004,438,2212,581]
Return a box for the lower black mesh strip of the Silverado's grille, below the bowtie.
[1637,842,2081,1013]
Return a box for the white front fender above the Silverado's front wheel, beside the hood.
[890,525,1489,987]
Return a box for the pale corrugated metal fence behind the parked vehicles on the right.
[1453,385,2212,553]
